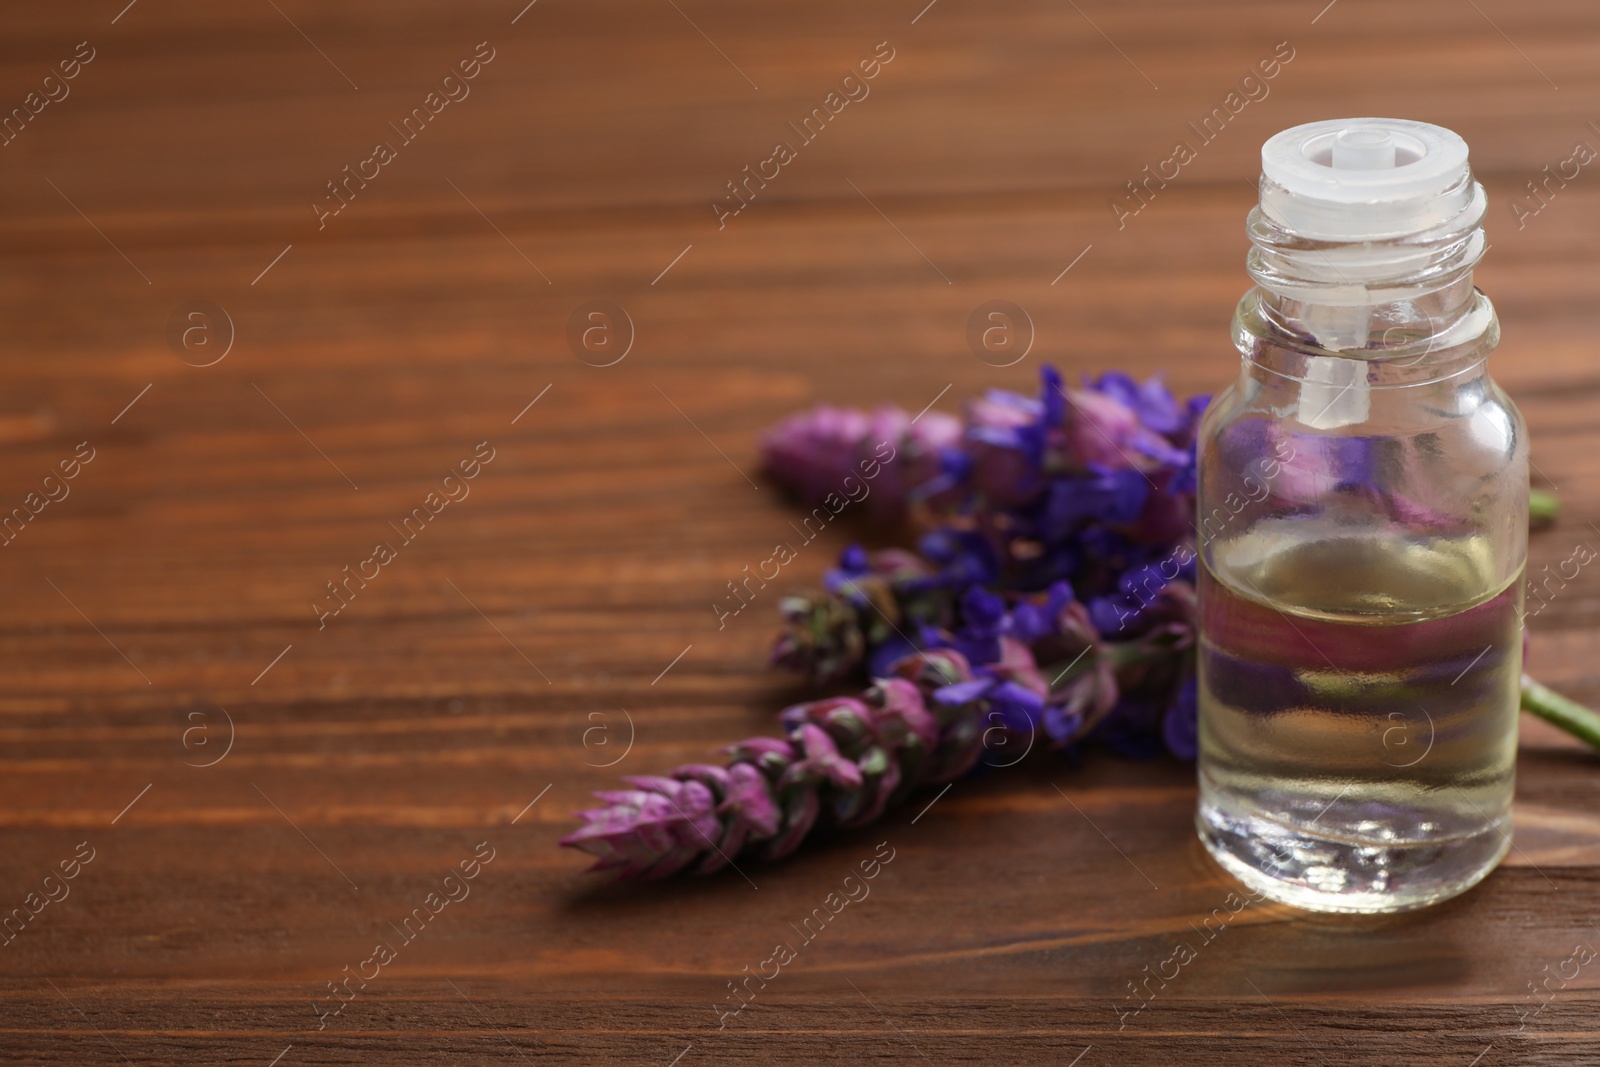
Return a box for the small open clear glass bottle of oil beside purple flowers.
[1197,118,1528,912]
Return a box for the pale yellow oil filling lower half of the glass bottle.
[1197,518,1522,912]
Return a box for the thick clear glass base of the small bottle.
[1195,776,1510,915]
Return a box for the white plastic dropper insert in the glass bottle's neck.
[1261,118,1480,429]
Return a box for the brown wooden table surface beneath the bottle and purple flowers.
[0,0,1600,1067]
